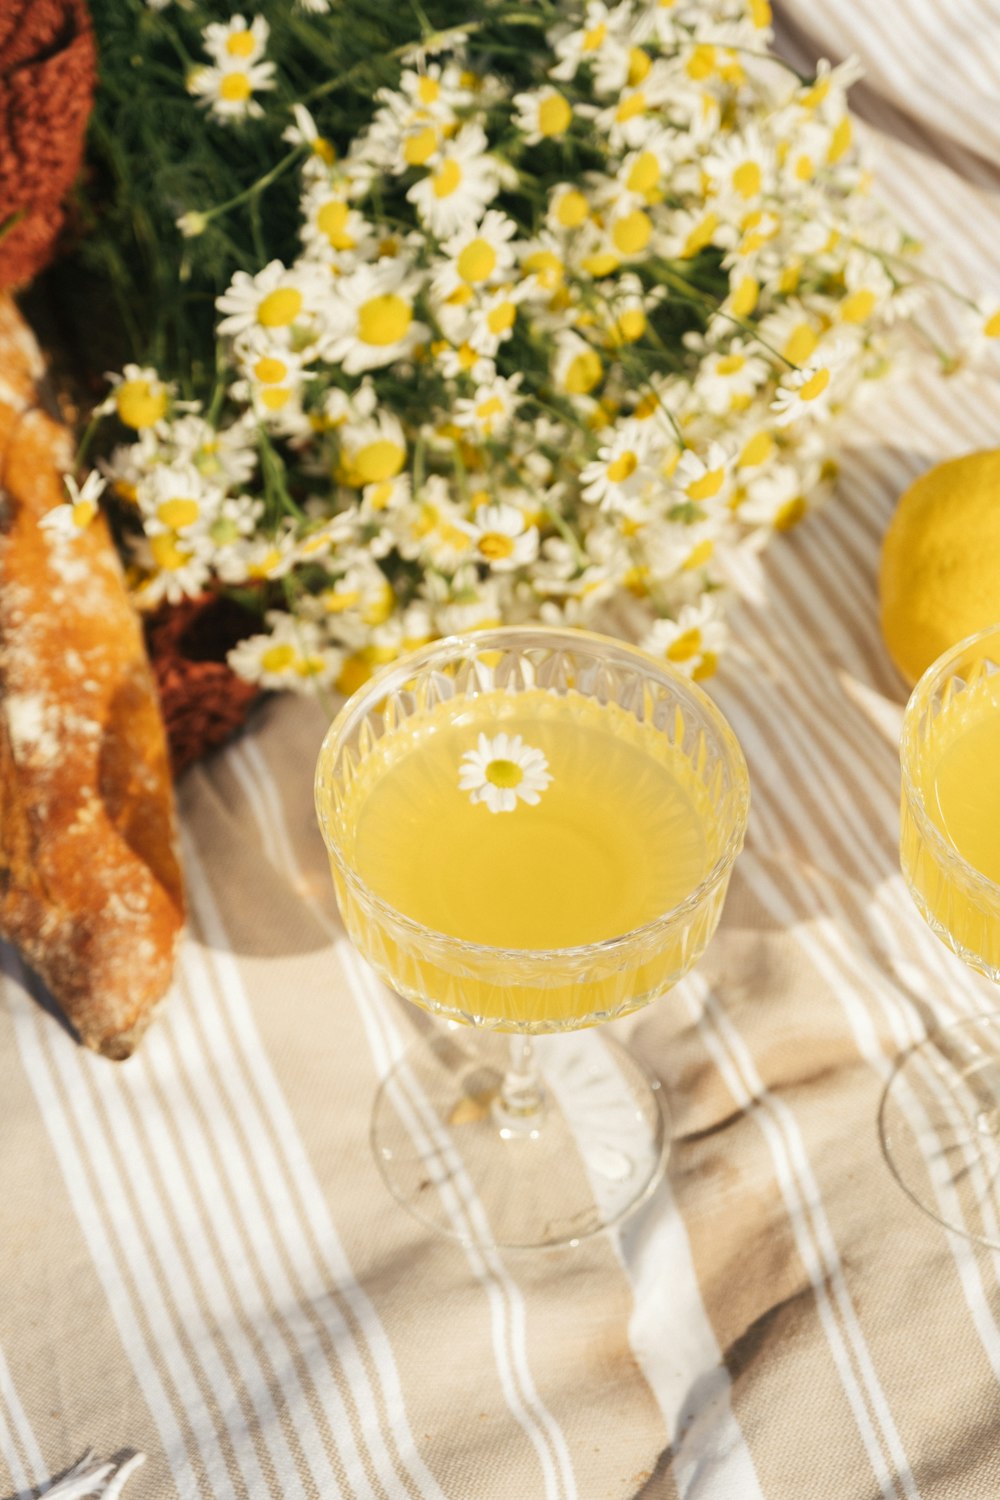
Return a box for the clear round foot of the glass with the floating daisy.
[372,1026,669,1250]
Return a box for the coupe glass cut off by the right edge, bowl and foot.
[880,626,1000,1248]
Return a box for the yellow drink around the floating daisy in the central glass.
[325,690,724,1031]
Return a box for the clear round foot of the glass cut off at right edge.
[879,1014,1000,1250]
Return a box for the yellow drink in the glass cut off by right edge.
[903,675,1000,980]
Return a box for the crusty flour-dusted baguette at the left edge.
[0,296,184,1059]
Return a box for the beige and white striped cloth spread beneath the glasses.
[0,0,1000,1500]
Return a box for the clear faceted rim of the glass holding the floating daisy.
[313,626,750,963]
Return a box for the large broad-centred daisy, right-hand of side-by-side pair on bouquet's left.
[324,258,430,375]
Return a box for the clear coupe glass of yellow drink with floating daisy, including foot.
[316,629,750,1247]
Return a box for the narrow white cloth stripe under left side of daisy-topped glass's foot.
[221,743,576,1500]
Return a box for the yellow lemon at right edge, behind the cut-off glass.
[879,450,1000,683]
